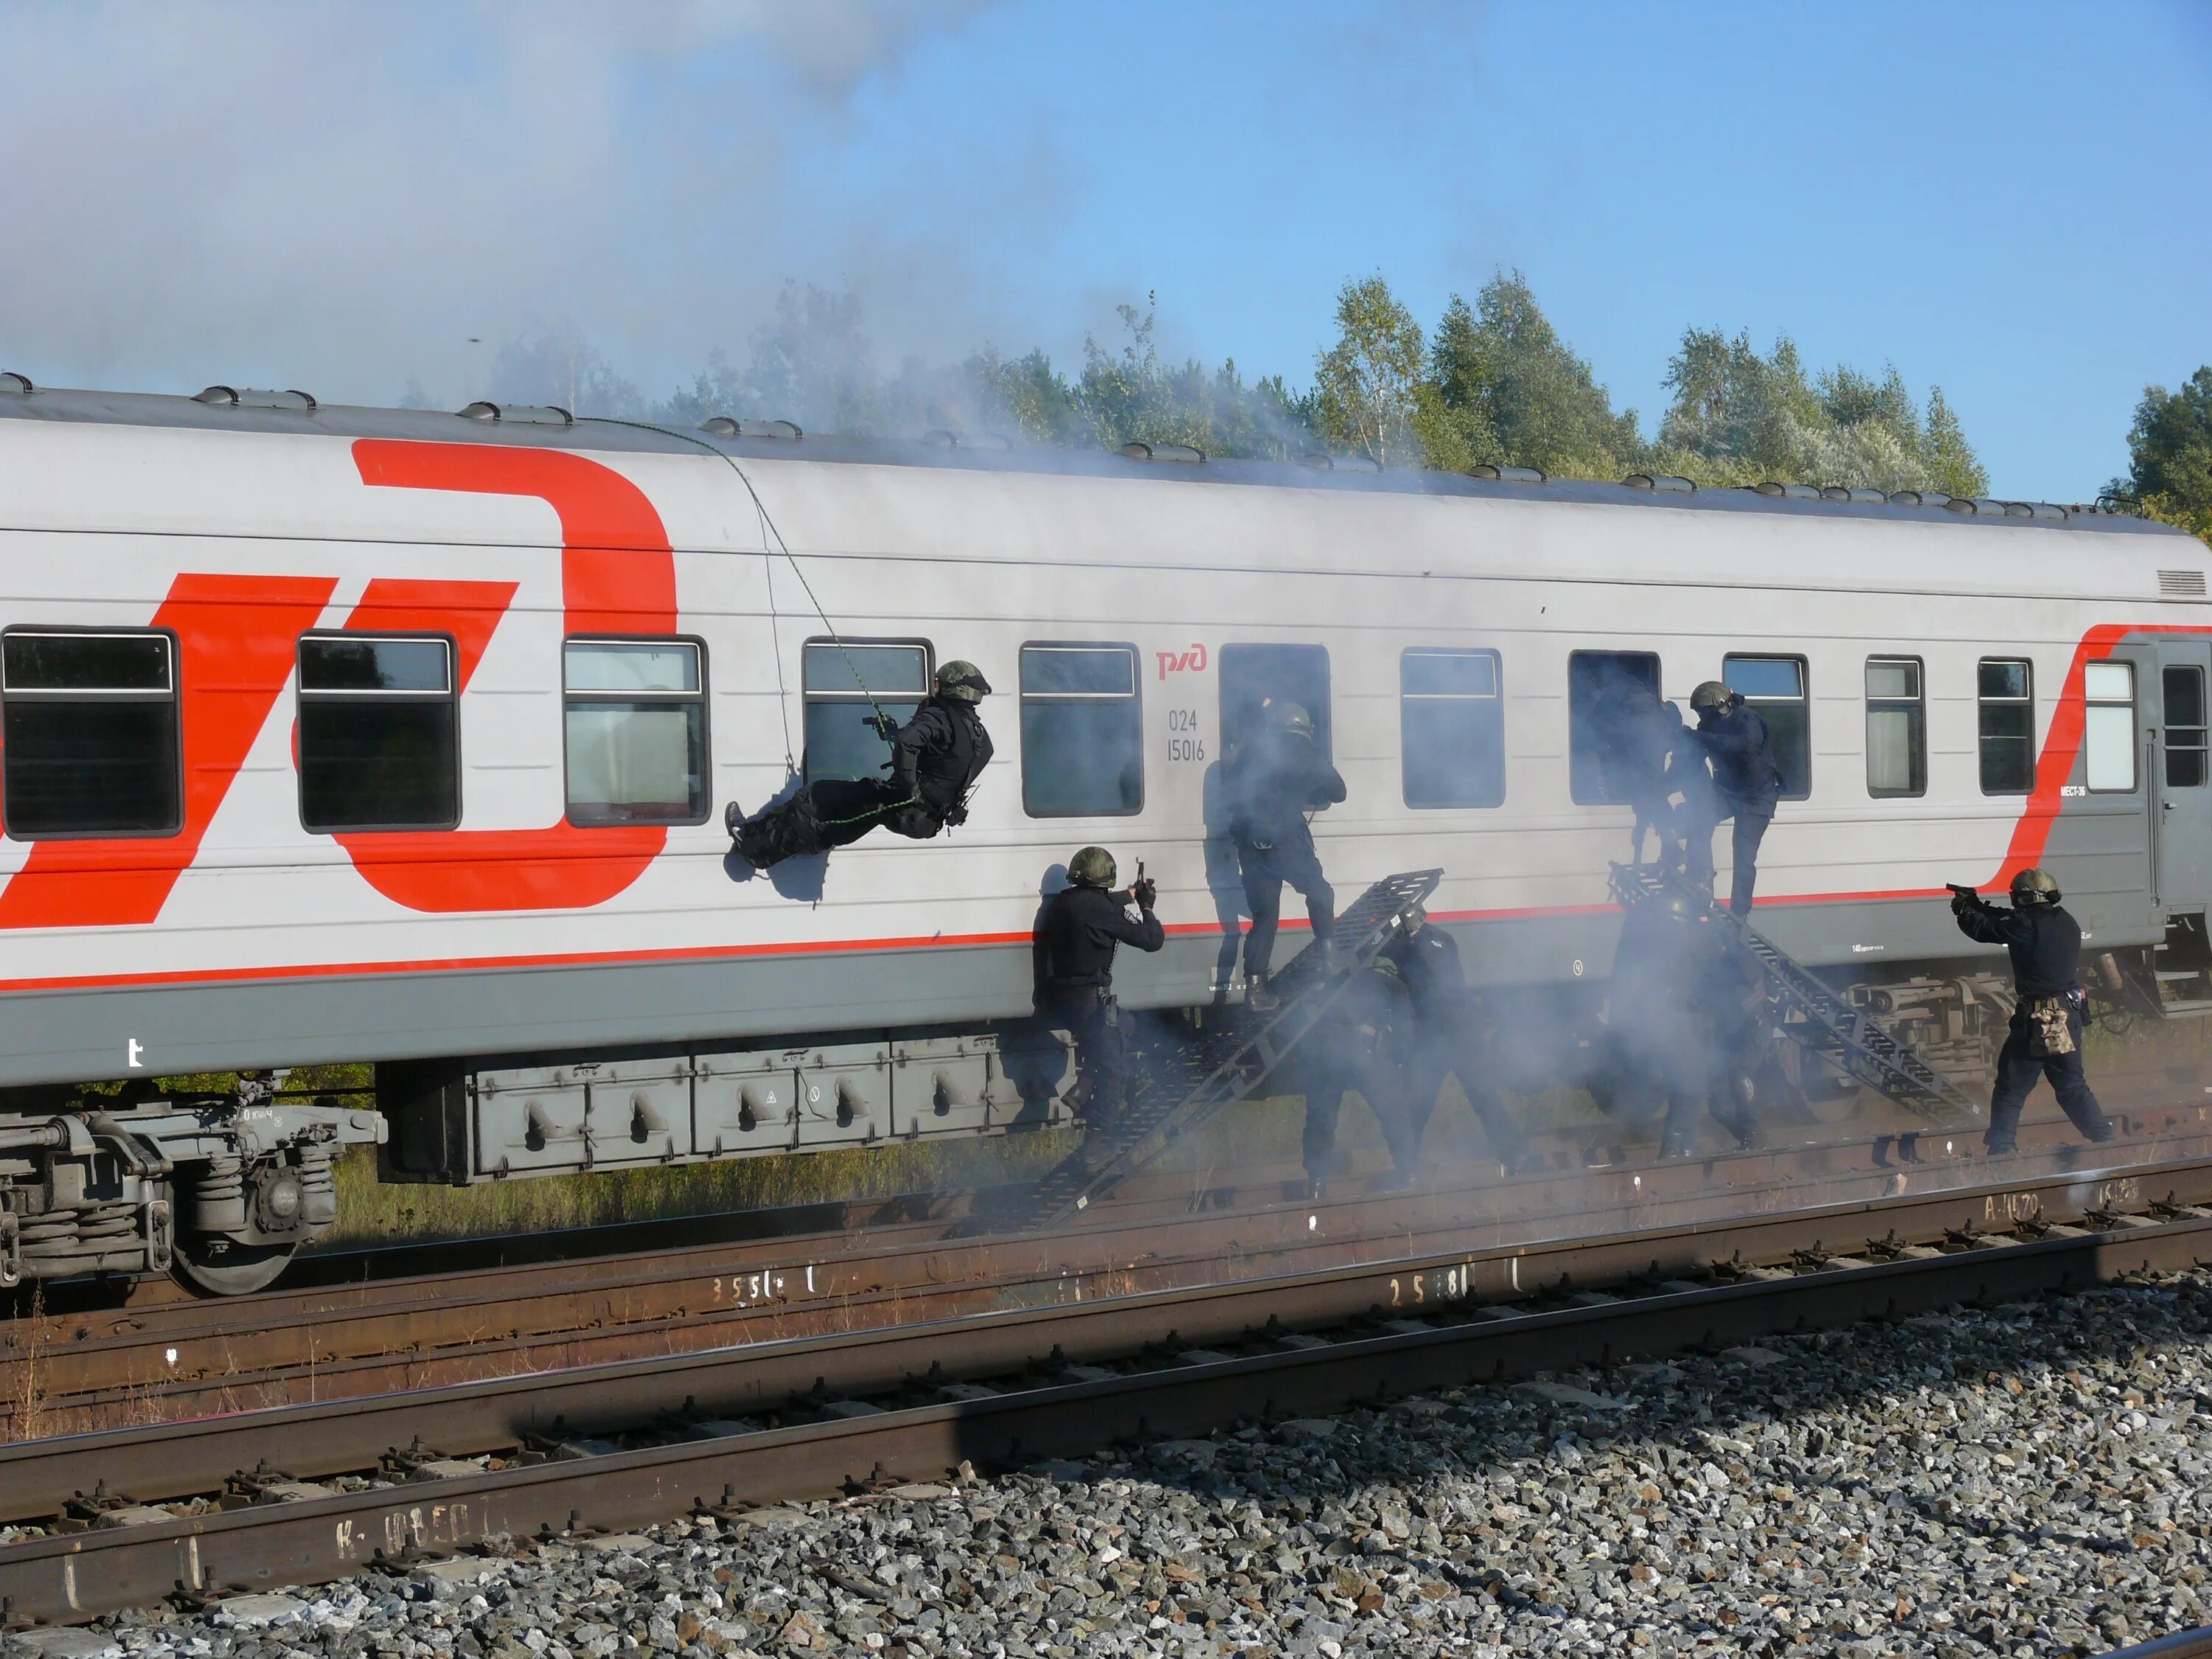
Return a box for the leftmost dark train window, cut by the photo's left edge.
[0,628,184,841]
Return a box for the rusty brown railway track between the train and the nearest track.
[17,1106,2212,1438]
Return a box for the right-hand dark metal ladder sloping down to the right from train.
[1613,865,1986,1128]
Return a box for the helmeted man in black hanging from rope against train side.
[721,661,991,869]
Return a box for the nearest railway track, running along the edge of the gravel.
[0,1159,2212,1624]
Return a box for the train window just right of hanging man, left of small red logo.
[1022,641,1144,818]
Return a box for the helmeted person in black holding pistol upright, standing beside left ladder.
[1033,847,1166,1130]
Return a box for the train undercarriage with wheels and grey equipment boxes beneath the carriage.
[0,918,2212,1294]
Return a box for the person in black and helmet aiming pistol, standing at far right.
[1951,869,2115,1155]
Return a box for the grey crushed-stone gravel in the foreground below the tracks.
[7,1272,2212,1659]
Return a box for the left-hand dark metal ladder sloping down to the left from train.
[962,869,1444,1232]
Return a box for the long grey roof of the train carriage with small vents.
[0,376,2194,540]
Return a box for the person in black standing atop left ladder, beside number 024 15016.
[1221,703,1345,1013]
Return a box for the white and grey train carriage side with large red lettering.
[0,392,2212,1283]
